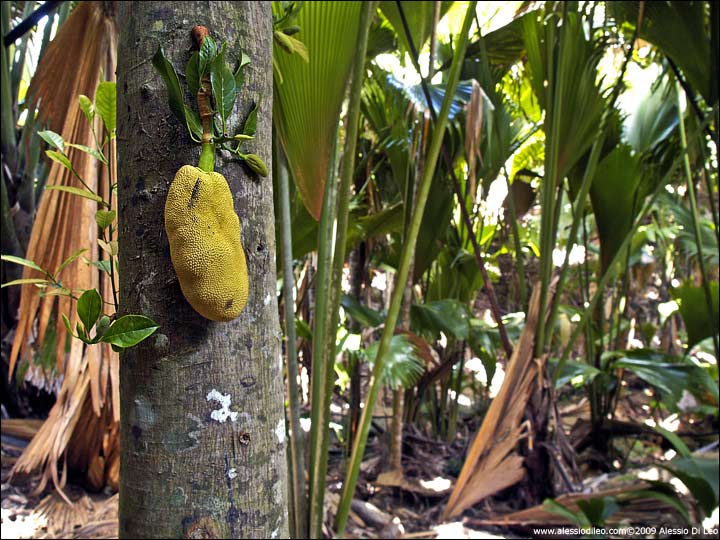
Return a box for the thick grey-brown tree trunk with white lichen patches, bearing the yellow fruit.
[117,1,288,538]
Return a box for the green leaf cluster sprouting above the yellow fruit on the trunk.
[152,36,268,176]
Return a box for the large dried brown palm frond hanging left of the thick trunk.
[10,2,120,496]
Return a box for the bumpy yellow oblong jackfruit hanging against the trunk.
[165,165,248,321]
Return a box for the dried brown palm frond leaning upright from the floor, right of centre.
[444,283,554,518]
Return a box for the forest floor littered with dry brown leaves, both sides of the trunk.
[1,392,717,538]
